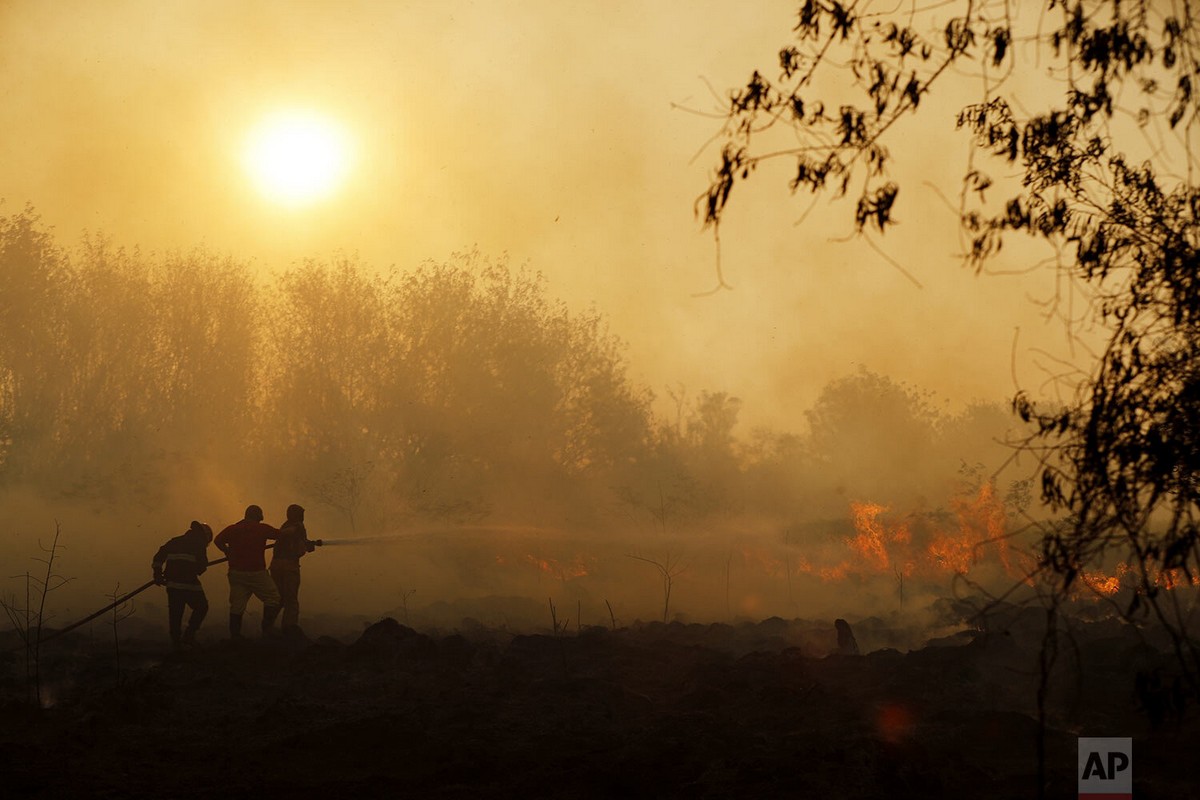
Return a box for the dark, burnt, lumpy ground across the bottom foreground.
[0,613,1200,800]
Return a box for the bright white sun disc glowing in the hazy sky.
[242,112,350,206]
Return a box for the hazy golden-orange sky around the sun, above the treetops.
[0,0,1063,429]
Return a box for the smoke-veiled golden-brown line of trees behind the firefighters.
[0,209,1009,533]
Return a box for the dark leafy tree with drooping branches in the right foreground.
[697,0,1200,687]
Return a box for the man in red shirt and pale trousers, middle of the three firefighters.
[212,505,280,639]
